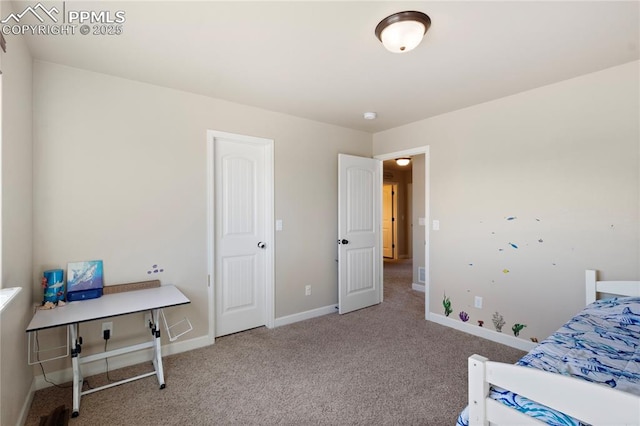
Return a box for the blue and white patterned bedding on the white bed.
[456,297,640,426]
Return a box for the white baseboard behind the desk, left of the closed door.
[33,336,211,392]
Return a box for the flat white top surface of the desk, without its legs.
[27,285,191,333]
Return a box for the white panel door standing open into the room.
[338,154,382,314]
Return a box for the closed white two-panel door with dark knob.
[214,133,273,336]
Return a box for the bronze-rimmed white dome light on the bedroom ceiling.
[376,11,431,53]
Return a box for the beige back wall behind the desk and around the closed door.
[33,62,371,366]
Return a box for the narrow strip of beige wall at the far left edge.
[0,2,33,425]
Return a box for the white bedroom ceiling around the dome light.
[9,0,640,132]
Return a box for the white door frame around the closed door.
[207,130,275,344]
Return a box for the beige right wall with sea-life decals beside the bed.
[373,62,640,340]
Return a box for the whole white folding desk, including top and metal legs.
[27,286,191,417]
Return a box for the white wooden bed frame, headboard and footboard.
[469,270,640,426]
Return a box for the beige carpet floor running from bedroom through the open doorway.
[26,261,523,426]
